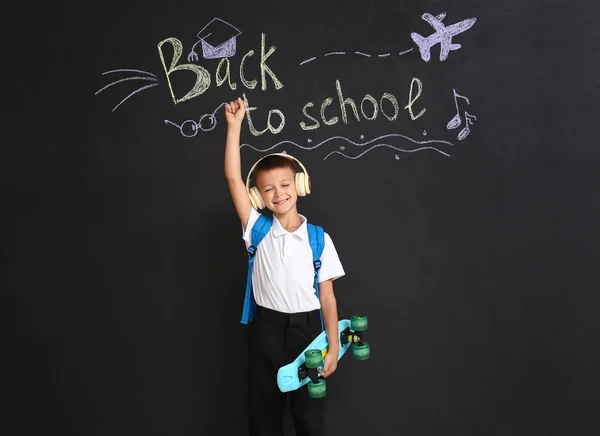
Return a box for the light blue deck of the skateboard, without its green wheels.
[277,317,368,392]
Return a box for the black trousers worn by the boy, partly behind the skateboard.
[249,306,325,436]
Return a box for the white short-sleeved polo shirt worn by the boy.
[242,209,345,313]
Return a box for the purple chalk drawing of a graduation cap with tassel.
[188,18,242,62]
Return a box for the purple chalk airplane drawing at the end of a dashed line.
[410,12,477,62]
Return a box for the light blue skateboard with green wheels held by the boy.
[277,315,371,398]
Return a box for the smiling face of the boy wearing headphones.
[256,168,298,214]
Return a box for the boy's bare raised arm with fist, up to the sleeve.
[225,98,252,228]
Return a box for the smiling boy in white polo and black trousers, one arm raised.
[225,98,344,436]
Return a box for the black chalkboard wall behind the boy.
[8,0,600,436]
